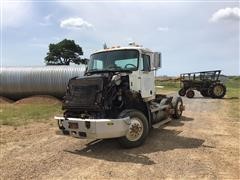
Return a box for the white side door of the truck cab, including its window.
[139,53,155,98]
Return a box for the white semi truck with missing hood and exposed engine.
[55,43,184,148]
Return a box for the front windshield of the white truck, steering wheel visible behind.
[88,50,139,72]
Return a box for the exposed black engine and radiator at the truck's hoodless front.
[63,72,139,118]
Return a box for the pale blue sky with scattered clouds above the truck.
[1,0,240,75]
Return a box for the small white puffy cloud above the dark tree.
[60,17,93,29]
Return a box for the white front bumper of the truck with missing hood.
[54,117,130,139]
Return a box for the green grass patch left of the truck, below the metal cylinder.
[0,103,62,126]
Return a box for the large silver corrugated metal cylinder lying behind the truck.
[0,65,85,99]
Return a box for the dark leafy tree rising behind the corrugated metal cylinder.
[44,39,87,65]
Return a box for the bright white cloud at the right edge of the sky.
[209,7,240,22]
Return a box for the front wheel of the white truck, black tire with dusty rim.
[118,109,149,148]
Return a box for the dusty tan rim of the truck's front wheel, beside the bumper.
[126,117,143,141]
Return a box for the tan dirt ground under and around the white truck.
[0,93,240,179]
